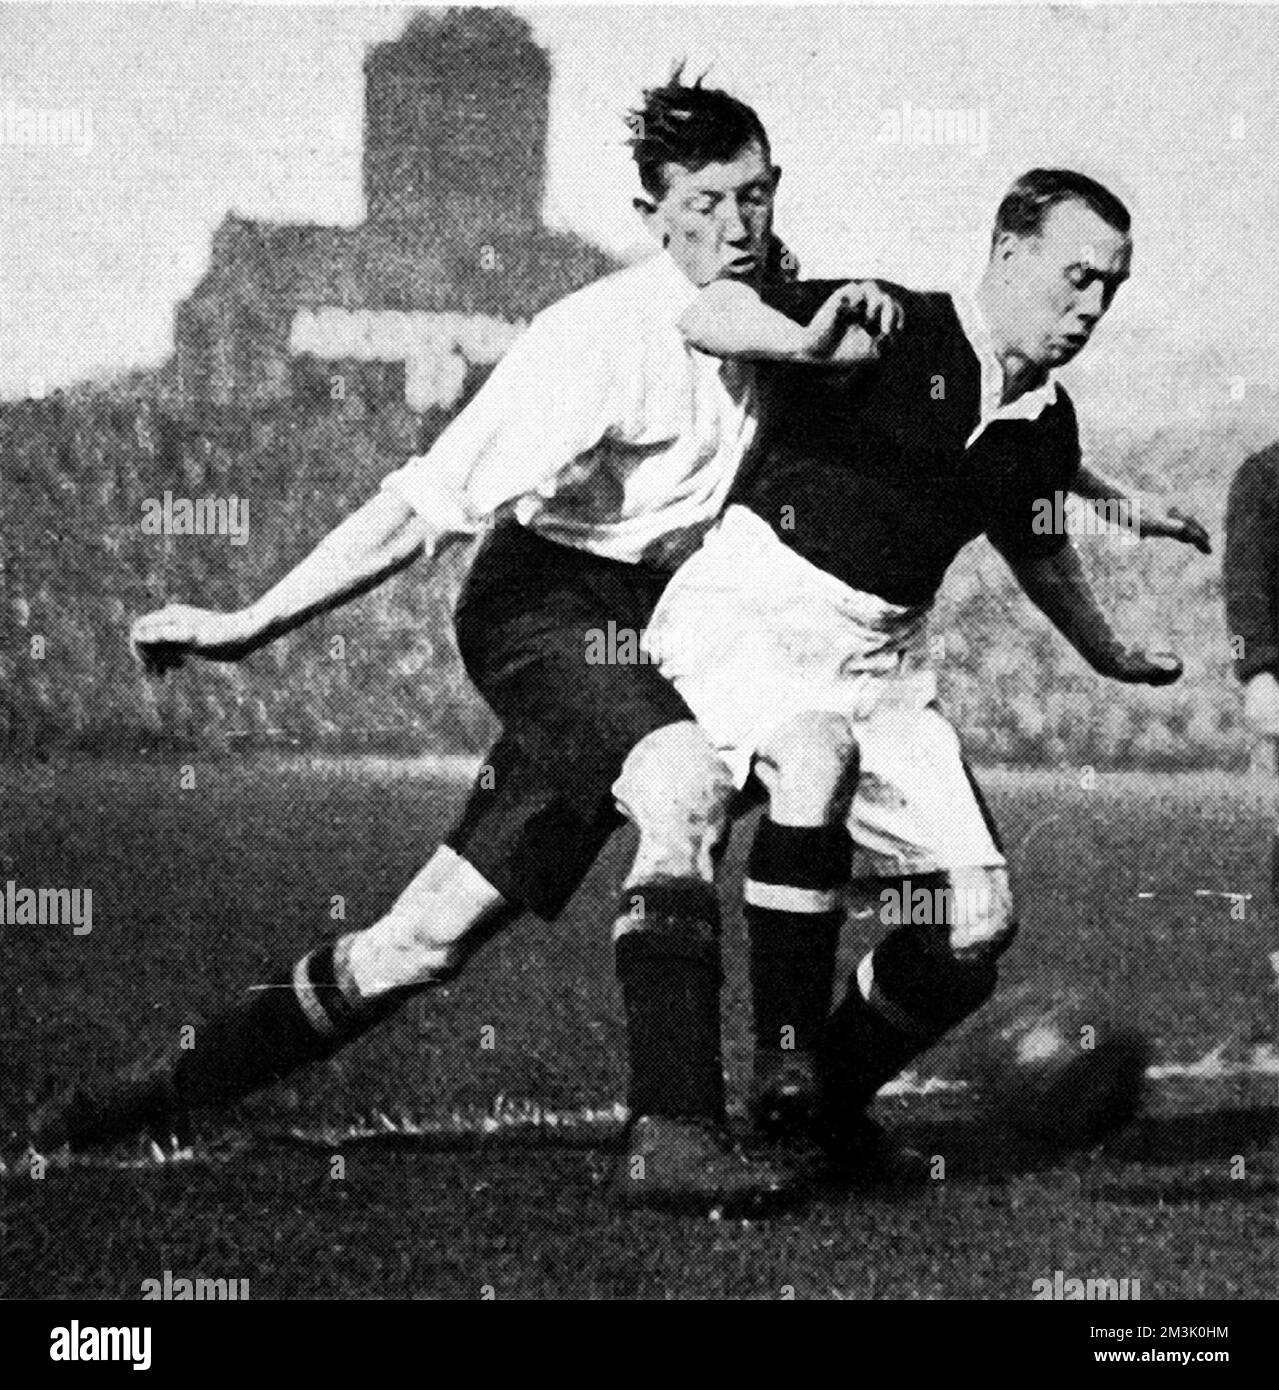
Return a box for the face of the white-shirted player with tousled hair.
[640,142,779,285]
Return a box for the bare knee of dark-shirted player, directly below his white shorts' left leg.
[755,710,858,826]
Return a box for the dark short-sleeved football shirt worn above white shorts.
[728,281,1080,606]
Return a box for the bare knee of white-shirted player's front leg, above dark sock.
[613,720,733,883]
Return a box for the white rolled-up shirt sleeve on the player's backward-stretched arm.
[382,306,624,534]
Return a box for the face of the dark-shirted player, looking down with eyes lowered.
[995,202,1133,368]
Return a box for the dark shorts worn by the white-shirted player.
[448,523,692,920]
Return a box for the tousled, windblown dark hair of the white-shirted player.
[626,63,769,197]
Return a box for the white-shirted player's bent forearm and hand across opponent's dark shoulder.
[680,279,902,367]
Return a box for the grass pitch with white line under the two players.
[0,759,1279,1300]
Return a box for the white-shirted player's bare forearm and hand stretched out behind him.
[131,492,438,670]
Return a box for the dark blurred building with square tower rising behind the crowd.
[167,10,616,411]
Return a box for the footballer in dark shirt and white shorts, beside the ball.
[646,170,1205,1155]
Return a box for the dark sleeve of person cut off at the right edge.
[1222,445,1279,681]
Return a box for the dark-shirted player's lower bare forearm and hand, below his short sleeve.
[1008,542,1182,685]
